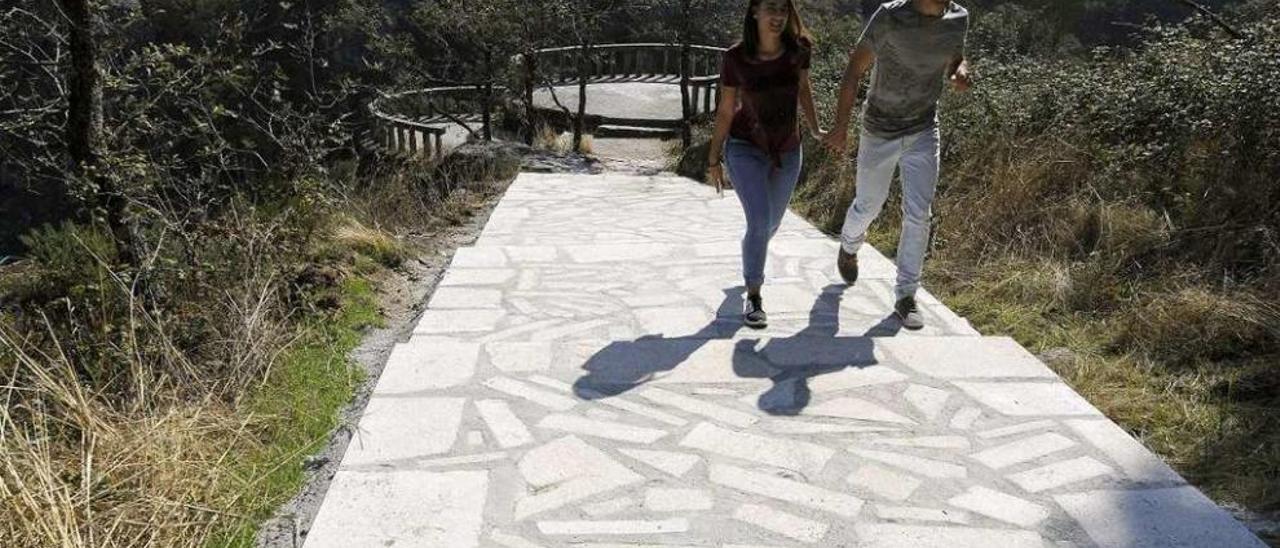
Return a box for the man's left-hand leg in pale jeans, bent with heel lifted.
[840,131,901,255]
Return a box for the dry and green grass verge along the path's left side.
[0,147,518,548]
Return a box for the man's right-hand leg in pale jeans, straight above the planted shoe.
[895,128,938,300]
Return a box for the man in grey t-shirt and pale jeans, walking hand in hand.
[827,0,970,329]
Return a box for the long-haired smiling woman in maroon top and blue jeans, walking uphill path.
[707,0,824,328]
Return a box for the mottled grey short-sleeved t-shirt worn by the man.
[858,0,969,138]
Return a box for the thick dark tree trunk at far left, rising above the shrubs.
[60,0,138,266]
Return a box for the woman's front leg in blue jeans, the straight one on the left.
[723,140,771,294]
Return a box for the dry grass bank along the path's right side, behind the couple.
[778,128,1280,512]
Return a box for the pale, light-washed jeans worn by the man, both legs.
[840,127,938,298]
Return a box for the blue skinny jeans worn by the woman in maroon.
[723,138,803,288]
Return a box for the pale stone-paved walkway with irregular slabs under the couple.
[306,174,1262,548]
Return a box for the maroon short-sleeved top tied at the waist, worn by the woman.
[721,44,809,165]
